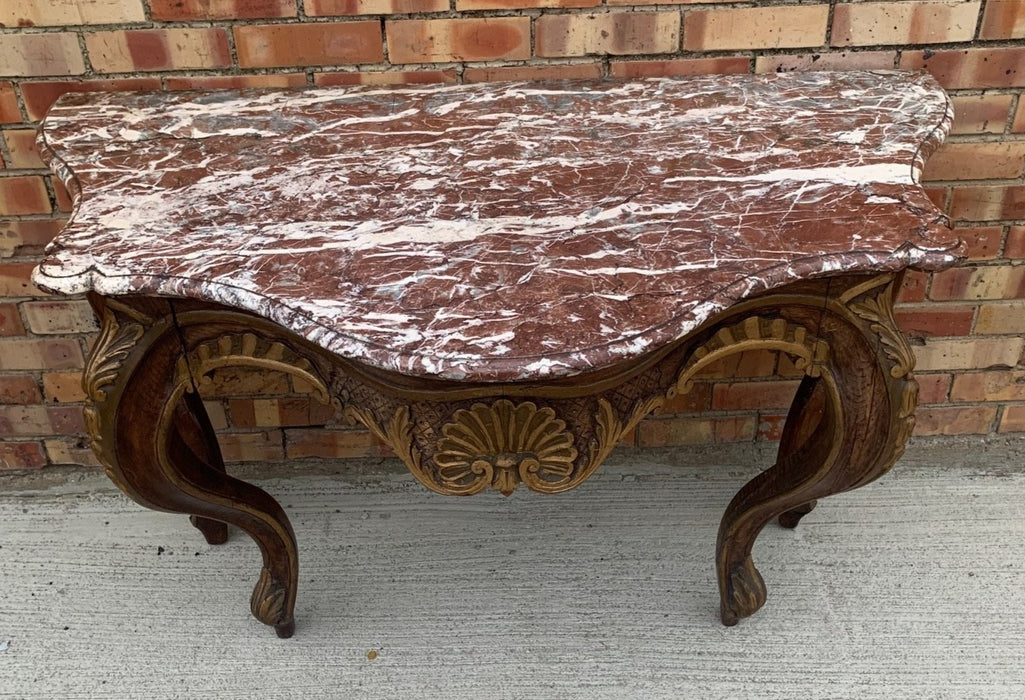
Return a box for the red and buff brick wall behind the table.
[0,0,1025,469]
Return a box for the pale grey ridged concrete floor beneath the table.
[0,439,1025,700]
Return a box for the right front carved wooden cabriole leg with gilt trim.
[716,278,917,625]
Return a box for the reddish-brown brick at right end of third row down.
[900,47,1025,89]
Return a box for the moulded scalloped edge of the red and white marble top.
[31,71,966,383]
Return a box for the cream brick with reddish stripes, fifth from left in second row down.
[534,11,680,56]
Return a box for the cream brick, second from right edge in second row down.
[832,0,981,46]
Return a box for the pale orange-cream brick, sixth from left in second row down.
[684,5,829,51]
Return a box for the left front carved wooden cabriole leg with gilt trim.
[83,298,298,637]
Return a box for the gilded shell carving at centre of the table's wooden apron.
[435,399,577,496]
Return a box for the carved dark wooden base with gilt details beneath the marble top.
[83,274,917,637]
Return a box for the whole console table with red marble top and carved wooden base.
[34,71,961,636]
